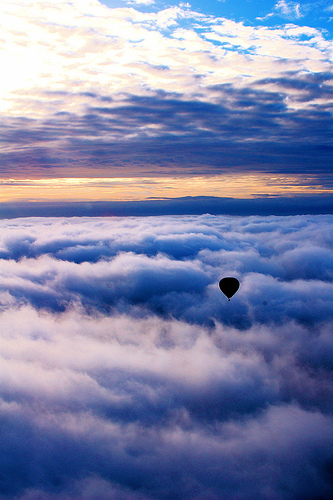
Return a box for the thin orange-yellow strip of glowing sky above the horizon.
[0,173,333,202]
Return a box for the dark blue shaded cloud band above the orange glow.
[1,83,331,182]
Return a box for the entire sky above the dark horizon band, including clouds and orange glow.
[0,0,333,216]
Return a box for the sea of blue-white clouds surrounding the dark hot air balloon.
[0,214,333,500]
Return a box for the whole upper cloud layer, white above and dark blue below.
[0,0,332,185]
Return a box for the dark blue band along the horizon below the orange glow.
[0,193,333,219]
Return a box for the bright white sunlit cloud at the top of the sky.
[0,0,330,117]
